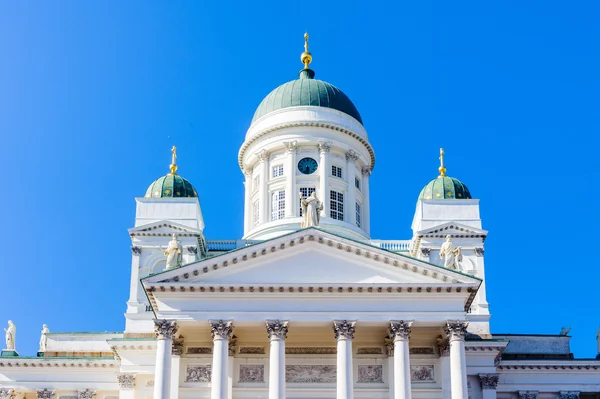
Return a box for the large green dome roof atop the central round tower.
[252,69,362,124]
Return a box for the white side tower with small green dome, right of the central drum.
[412,148,490,338]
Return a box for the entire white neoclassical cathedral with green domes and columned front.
[0,33,600,399]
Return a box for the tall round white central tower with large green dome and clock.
[238,34,375,239]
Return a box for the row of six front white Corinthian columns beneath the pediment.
[154,320,468,399]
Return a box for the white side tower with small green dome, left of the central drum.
[125,147,207,333]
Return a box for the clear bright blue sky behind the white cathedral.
[0,1,600,358]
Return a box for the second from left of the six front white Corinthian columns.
[209,320,233,399]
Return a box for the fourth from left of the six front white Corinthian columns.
[333,320,356,399]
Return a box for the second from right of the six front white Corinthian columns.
[390,320,413,399]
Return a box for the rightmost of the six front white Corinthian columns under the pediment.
[444,320,469,399]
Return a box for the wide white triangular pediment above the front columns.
[144,229,481,289]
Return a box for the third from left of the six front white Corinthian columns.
[266,320,288,399]
